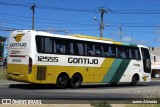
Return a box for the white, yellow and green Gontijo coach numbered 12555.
[7,30,151,88]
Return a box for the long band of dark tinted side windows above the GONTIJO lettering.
[36,36,141,60]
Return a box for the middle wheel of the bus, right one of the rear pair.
[70,74,82,88]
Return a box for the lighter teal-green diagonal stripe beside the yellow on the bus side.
[102,59,122,83]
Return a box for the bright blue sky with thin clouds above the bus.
[0,0,160,50]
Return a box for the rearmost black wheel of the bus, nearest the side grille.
[56,74,69,89]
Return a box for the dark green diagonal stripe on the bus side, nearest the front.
[111,59,131,83]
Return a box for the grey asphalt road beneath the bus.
[0,81,160,101]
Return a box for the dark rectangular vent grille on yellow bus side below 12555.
[37,67,46,80]
